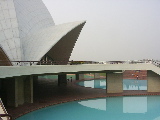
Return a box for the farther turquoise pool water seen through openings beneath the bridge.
[77,79,147,90]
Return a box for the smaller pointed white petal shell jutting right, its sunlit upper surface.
[22,21,85,61]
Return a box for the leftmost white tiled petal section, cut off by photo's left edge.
[0,0,21,61]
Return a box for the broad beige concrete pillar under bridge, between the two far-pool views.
[106,73,123,93]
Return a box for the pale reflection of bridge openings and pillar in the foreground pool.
[78,97,147,113]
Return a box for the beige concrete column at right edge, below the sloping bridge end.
[147,71,160,92]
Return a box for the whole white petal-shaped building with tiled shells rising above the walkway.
[0,0,85,65]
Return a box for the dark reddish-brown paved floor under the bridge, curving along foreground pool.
[7,80,160,118]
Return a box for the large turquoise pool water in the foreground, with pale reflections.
[16,96,160,120]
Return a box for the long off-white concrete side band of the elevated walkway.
[0,64,160,78]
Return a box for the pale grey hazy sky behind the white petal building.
[43,0,160,61]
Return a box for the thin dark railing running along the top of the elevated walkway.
[0,60,156,67]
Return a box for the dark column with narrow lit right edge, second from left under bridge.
[24,76,33,103]
